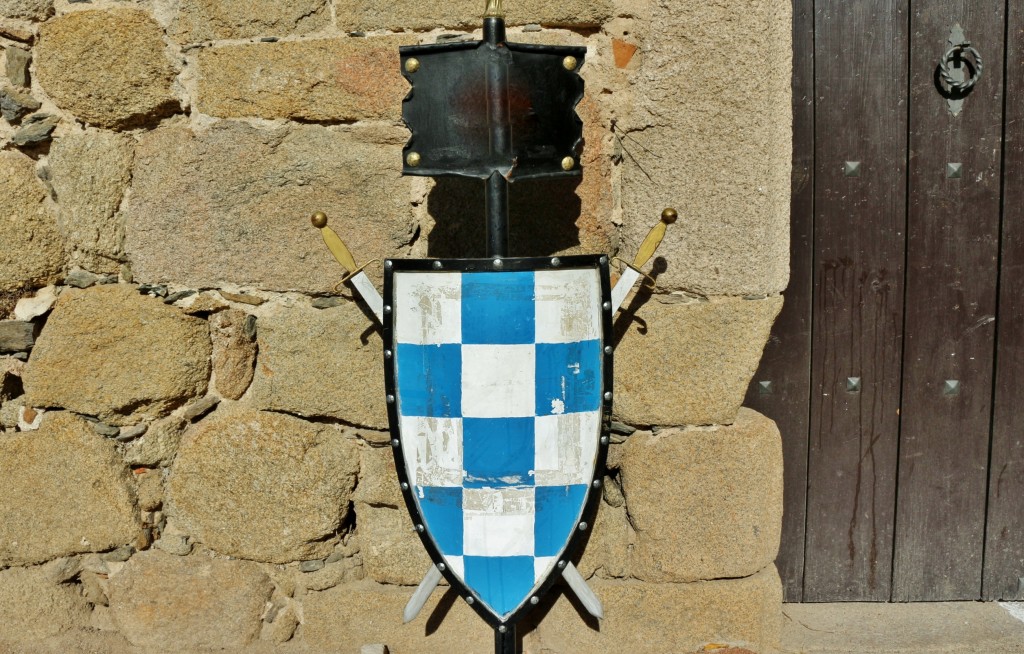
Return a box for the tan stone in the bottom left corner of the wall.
[0,567,89,652]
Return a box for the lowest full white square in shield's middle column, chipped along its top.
[463,488,535,557]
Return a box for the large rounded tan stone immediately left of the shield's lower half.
[167,407,358,563]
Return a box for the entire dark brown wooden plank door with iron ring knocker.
[748,0,1024,602]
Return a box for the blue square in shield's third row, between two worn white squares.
[462,418,536,488]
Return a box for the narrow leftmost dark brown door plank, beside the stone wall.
[745,0,814,602]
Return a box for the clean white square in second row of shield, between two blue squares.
[462,345,537,418]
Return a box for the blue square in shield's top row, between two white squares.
[462,272,537,345]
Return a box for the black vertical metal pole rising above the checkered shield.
[483,16,512,257]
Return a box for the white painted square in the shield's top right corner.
[534,268,601,343]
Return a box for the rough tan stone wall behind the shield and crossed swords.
[0,0,791,654]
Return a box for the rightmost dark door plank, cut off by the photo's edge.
[983,2,1024,600]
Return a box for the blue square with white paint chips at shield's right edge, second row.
[536,341,601,416]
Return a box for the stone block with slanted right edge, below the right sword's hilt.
[614,292,782,425]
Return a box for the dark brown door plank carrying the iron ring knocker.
[893,0,1004,602]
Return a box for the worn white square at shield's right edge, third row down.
[534,411,601,486]
